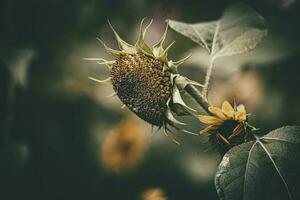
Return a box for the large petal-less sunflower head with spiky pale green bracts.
[86,19,202,141]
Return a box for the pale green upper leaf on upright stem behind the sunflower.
[169,3,267,59]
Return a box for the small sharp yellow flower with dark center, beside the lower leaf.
[198,101,247,145]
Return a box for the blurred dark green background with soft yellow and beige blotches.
[0,0,300,200]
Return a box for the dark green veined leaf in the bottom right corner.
[215,126,300,200]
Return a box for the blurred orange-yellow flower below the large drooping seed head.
[101,120,147,172]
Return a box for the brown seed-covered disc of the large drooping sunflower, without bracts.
[111,52,172,126]
